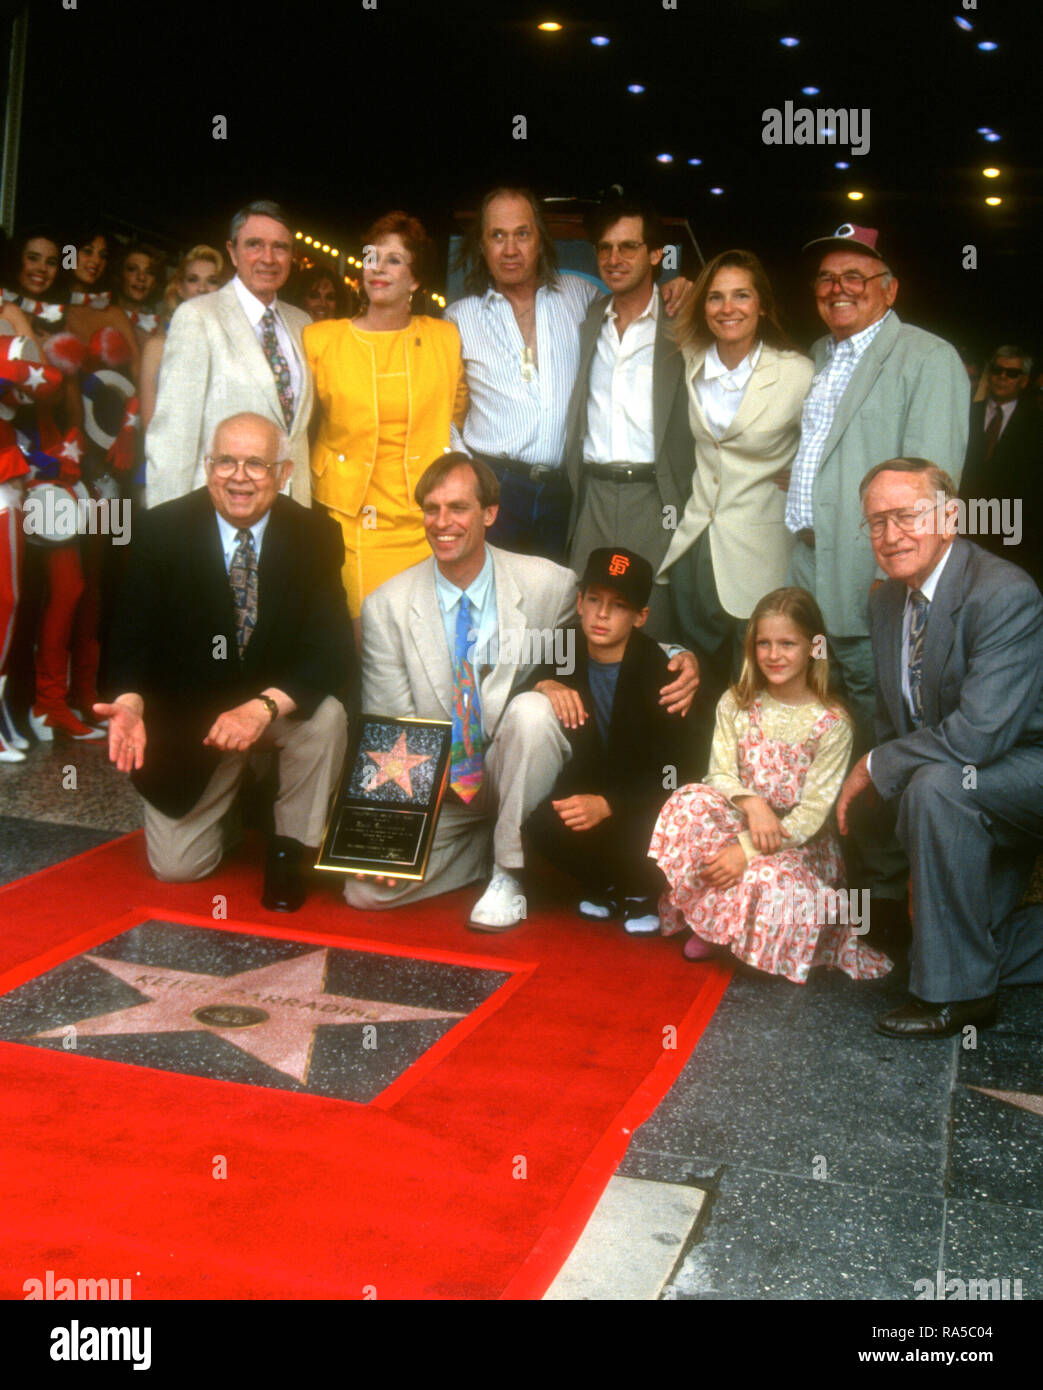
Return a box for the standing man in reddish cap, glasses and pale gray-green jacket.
[786,222,969,746]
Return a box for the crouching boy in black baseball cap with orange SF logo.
[524,546,688,933]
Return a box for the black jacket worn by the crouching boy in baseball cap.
[538,628,691,824]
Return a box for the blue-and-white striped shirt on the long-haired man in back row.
[445,275,599,467]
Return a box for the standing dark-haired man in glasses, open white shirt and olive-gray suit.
[565,199,695,637]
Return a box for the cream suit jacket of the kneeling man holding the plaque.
[362,546,576,739]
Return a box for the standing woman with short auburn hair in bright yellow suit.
[303,213,467,632]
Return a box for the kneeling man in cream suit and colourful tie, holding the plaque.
[345,453,697,931]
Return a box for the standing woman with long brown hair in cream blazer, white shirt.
[658,250,814,695]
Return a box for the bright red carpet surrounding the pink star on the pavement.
[0,835,729,1300]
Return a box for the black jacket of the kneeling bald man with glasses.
[103,488,357,816]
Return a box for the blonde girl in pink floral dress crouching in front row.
[649,588,891,984]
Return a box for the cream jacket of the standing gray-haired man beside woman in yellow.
[145,282,314,507]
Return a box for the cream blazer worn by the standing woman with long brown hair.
[659,343,814,619]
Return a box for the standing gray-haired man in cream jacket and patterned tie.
[145,202,314,507]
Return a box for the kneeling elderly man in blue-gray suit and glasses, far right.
[837,459,1043,1038]
